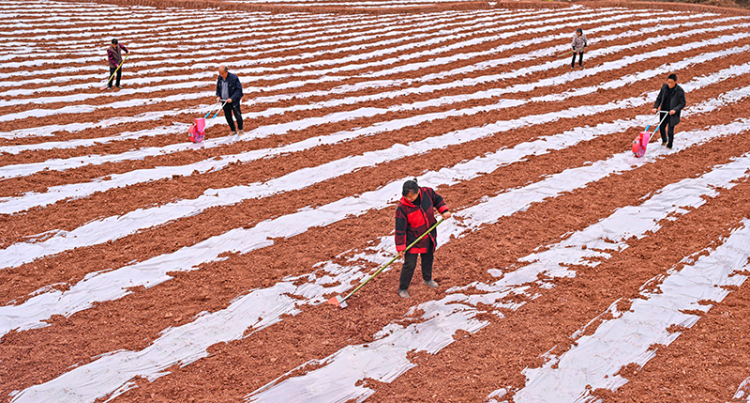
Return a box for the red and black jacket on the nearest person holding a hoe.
[396,187,448,253]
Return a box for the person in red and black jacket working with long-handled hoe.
[396,179,451,298]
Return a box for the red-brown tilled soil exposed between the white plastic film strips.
[0,0,750,402]
